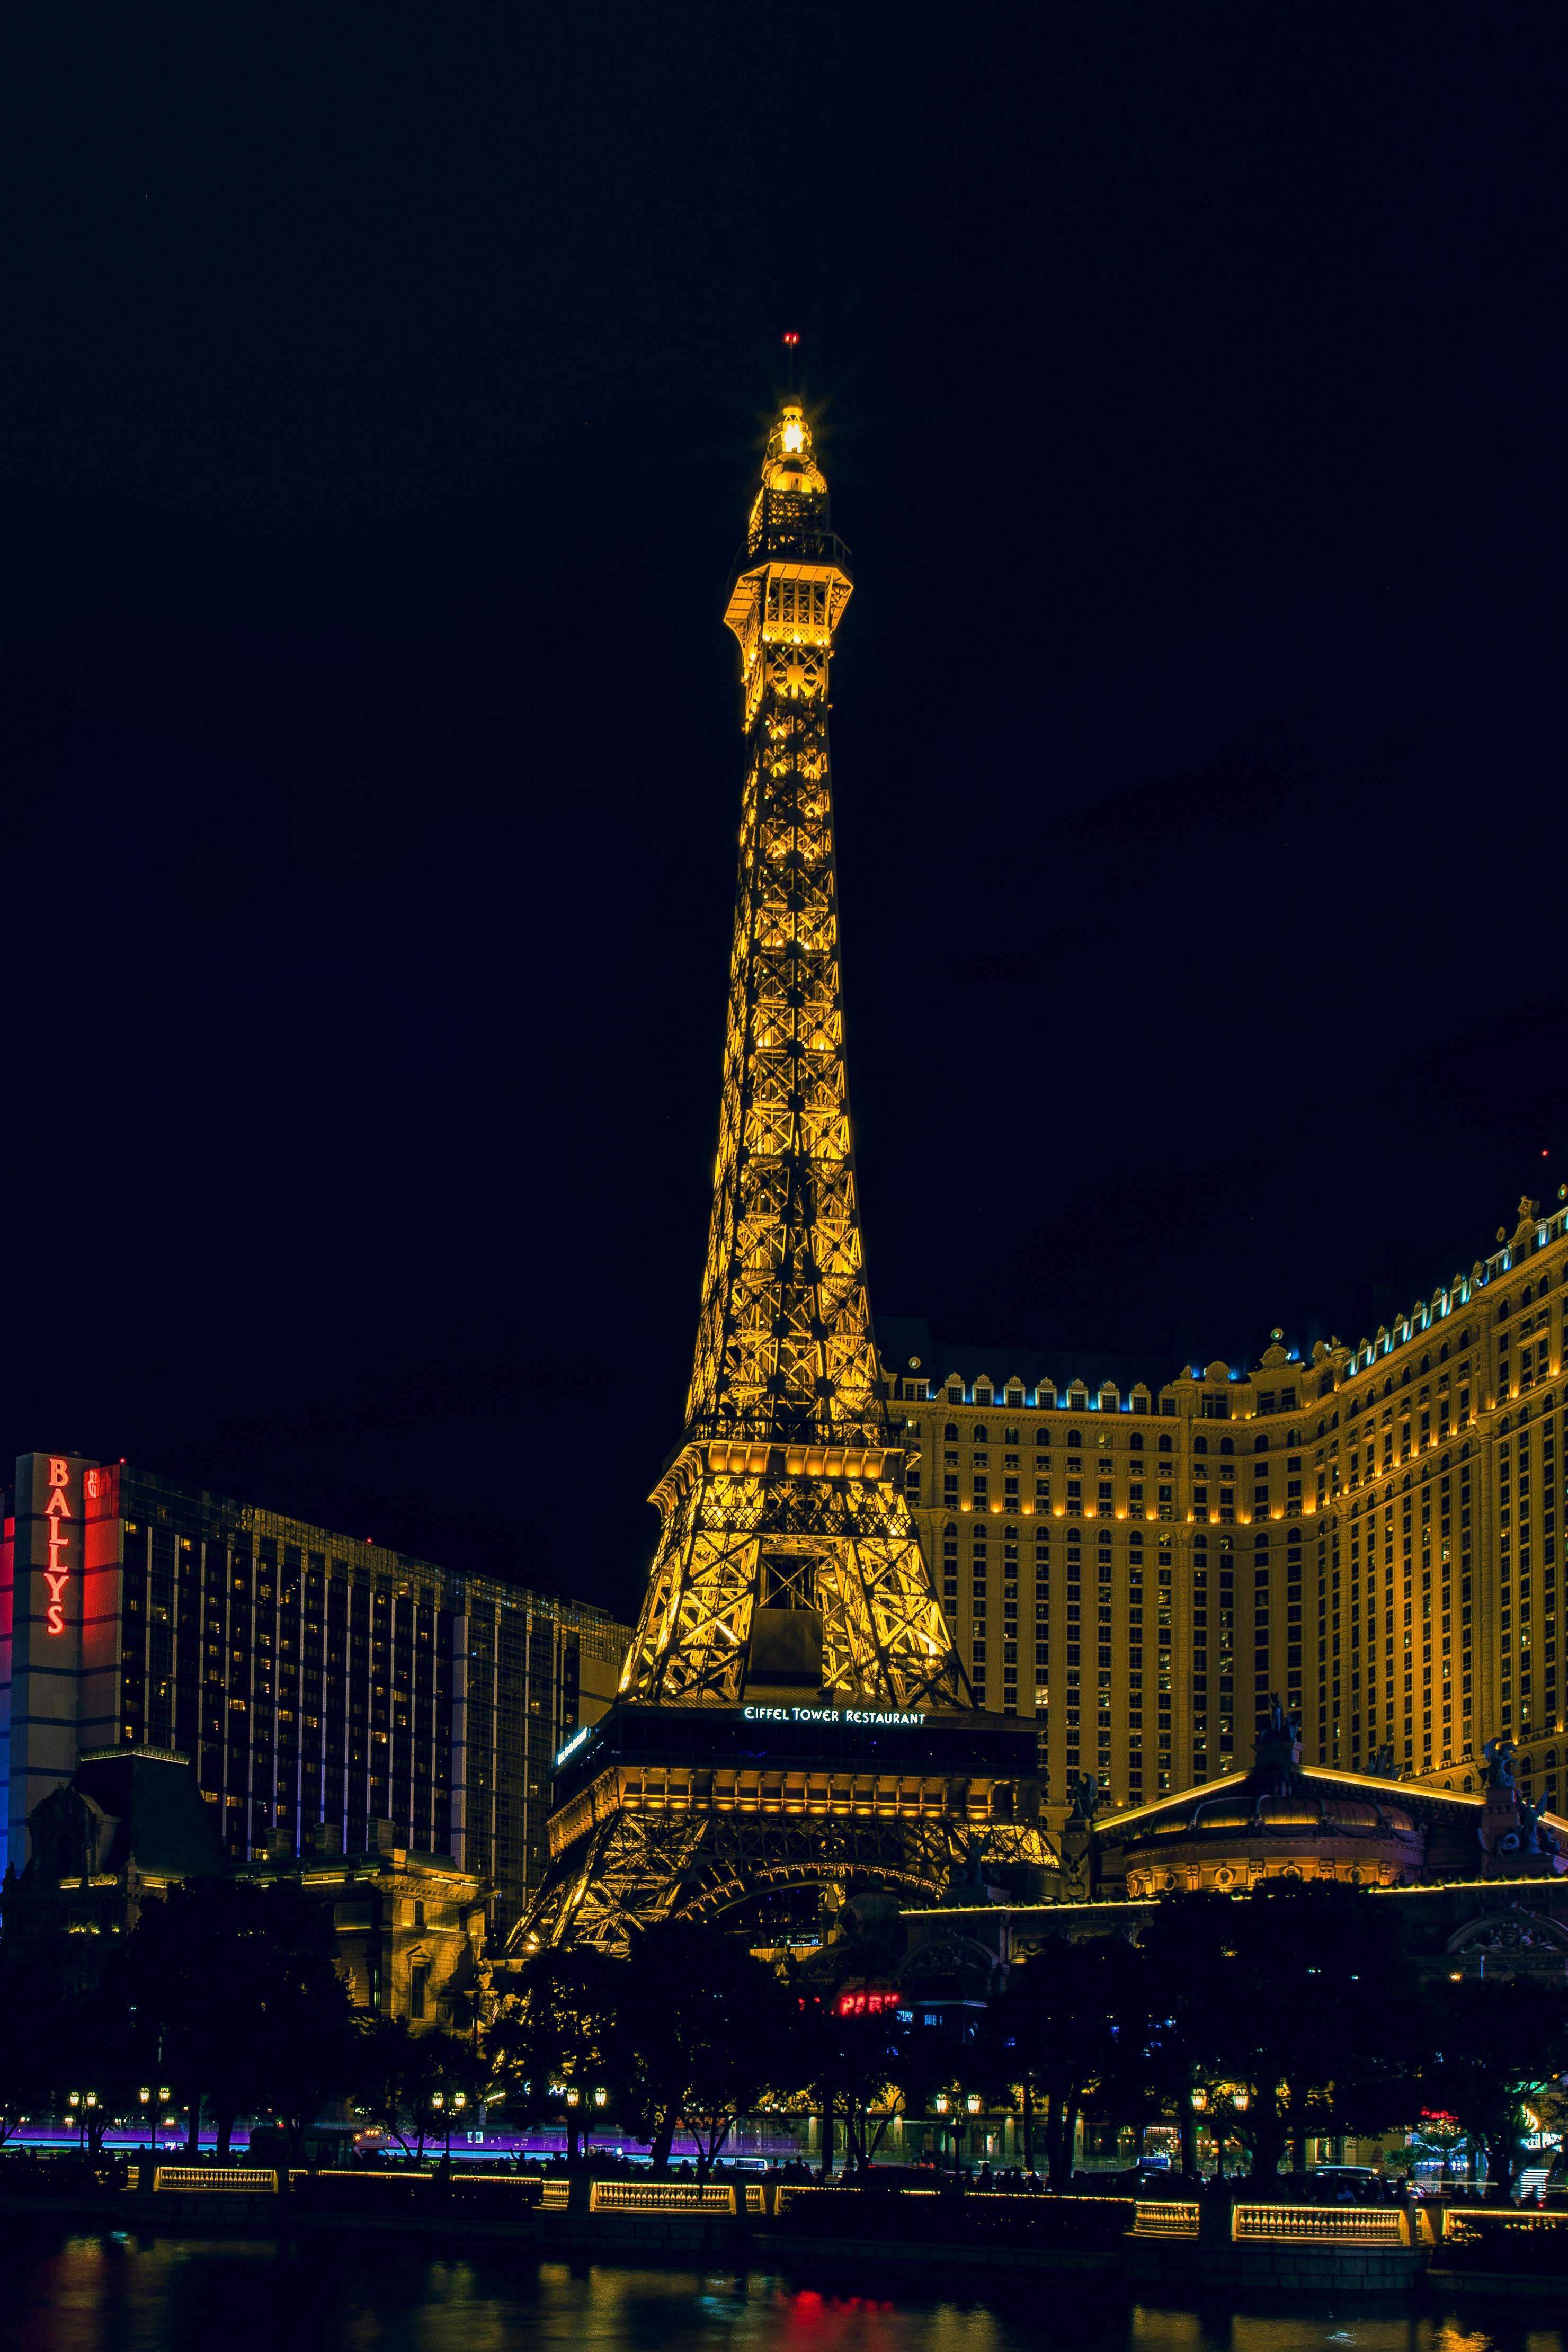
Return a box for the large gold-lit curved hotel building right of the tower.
[879,1202,1568,1806]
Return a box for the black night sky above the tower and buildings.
[0,0,1568,1611]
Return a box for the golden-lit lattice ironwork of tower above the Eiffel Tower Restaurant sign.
[621,400,971,1707]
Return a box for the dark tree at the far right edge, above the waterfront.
[1420,1978,1568,2197]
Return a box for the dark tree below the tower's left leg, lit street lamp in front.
[484,1945,630,2161]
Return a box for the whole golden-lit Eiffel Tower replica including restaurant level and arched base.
[512,400,1048,1952]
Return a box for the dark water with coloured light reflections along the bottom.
[0,2220,1568,2352]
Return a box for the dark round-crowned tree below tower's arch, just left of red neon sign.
[618,1921,792,2178]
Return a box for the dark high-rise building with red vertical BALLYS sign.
[0,1454,628,1934]
